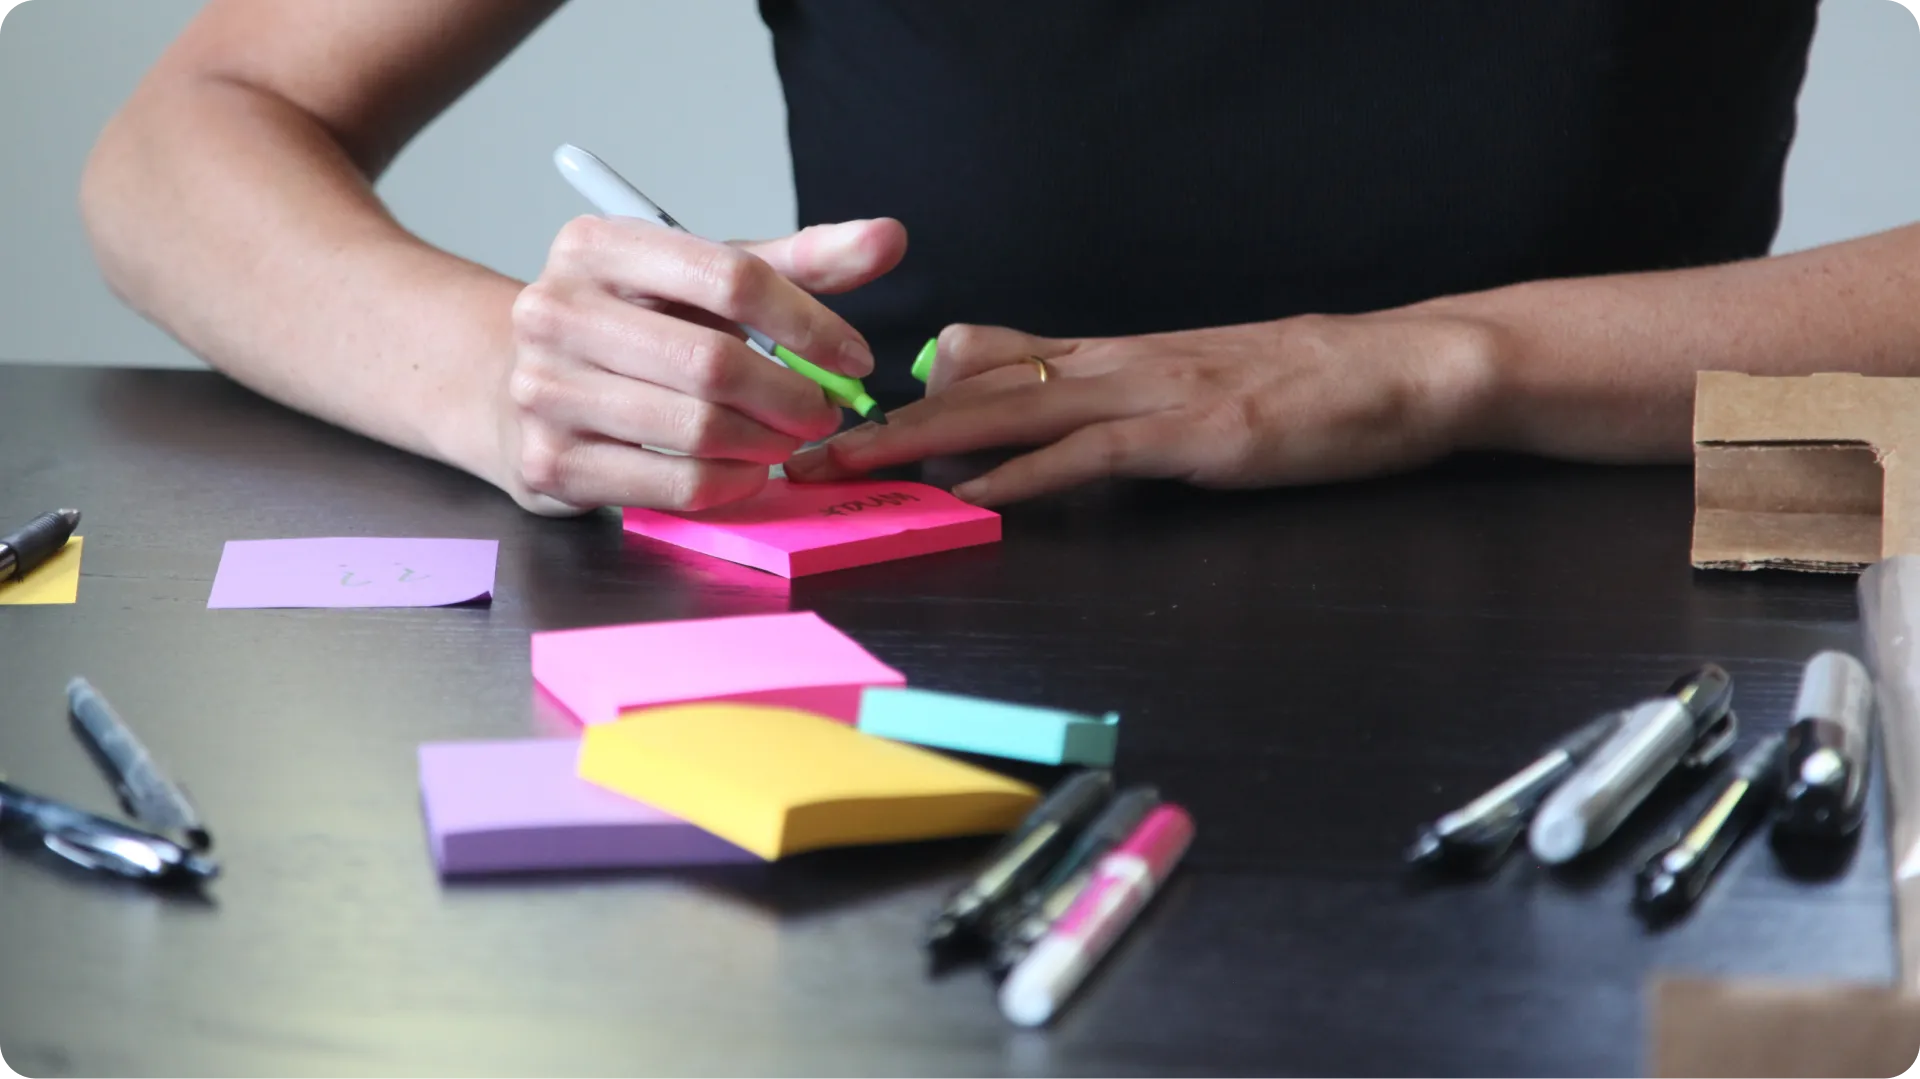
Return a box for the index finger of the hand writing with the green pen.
[547,217,874,378]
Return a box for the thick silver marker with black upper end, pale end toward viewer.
[1526,664,1740,866]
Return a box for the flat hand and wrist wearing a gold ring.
[787,309,1498,505]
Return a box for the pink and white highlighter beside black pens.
[1000,804,1194,1027]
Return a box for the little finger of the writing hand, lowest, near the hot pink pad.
[520,430,766,511]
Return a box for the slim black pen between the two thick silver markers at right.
[1634,733,1788,922]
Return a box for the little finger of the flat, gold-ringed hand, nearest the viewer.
[954,413,1187,505]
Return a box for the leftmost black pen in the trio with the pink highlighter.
[925,770,1114,950]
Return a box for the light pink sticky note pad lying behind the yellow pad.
[532,611,906,724]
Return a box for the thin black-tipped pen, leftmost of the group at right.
[1405,712,1626,870]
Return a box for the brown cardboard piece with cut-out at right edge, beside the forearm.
[1693,371,1920,572]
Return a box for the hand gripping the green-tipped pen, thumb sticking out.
[501,217,906,515]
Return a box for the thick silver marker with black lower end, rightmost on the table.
[1774,651,1874,839]
